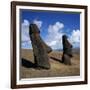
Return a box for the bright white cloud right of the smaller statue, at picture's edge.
[69,29,80,47]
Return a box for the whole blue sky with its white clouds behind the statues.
[20,10,80,49]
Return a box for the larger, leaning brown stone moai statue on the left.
[29,24,52,69]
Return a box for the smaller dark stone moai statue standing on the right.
[62,35,72,65]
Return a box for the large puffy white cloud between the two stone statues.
[45,22,64,49]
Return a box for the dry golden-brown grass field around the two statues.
[20,49,80,78]
